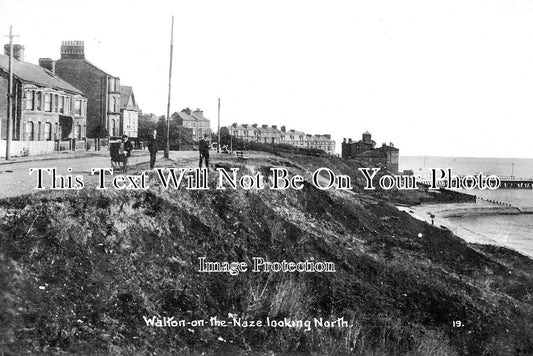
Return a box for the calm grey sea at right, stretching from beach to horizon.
[399,156,533,258]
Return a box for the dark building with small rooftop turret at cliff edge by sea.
[342,131,400,173]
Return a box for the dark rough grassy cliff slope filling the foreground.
[0,154,533,355]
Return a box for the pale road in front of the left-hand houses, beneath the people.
[0,151,202,199]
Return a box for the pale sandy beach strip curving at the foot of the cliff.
[397,202,533,259]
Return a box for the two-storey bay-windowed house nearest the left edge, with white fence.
[0,45,87,156]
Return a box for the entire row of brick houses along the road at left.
[0,41,140,156]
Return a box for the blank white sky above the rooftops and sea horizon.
[0,0,533,158]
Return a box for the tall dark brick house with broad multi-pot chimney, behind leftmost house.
[50,41,123,137]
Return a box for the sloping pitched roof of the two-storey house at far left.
[0,54,84,95]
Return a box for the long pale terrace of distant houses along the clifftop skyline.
[227,123,335,154]
